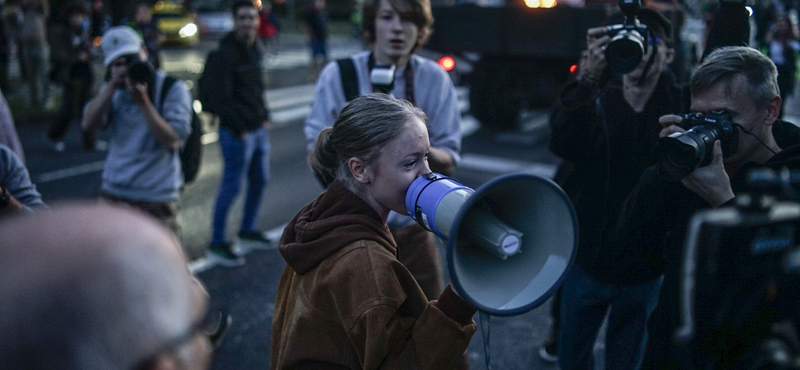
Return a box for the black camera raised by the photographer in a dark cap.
[606,0,650,75]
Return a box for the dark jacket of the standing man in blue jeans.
[205,33,269,137]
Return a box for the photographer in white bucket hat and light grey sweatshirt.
[81,26,192,232]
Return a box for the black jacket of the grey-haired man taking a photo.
[617,137,800,369]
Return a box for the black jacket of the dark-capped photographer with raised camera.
[550,72,684,284]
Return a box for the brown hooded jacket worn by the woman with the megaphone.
[270,180,476,370]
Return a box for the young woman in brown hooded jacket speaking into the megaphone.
[271,94,476,369]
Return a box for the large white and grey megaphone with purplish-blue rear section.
[406,172,578,316]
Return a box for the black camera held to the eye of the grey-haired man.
[655,110,739,180]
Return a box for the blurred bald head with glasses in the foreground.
[0,203,211,370]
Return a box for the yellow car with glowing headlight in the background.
[151,1,199,46]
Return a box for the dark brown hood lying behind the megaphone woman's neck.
[278,180,397,275]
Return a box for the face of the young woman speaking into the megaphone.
[366,117,431,214]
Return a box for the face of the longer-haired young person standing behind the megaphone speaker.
[374,0,419,64]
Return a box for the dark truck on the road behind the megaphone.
[425,0,618,130]
